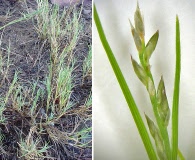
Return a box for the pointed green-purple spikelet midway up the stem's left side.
[131,57,148,86]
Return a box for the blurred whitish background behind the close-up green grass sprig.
[93,0,195,160]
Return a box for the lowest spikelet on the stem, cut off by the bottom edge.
[145,114,167,160]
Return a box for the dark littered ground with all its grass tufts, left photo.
[0,0,92,160]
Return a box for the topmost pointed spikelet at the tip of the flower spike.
[134,3,145,41]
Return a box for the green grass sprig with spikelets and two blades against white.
[94,4,184,160]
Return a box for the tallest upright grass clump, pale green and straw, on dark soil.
[36,0,82,123]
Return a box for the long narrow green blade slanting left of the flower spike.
[93,5,157,160]
